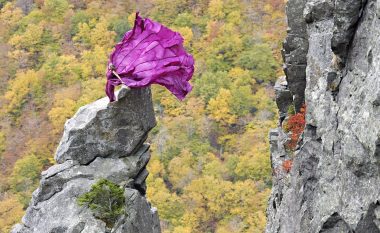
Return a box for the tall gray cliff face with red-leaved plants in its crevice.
[266,0,380,233]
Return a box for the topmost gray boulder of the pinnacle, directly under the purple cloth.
[55,88,156,164]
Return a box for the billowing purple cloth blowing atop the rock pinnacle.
[106,13,194,102]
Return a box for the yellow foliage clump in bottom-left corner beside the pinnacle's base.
[0,196,24,233]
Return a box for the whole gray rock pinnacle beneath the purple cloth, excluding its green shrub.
[12,88,161,233]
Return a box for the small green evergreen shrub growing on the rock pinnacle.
[78,179,125,228]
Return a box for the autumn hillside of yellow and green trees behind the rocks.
[0,0,286,233]
